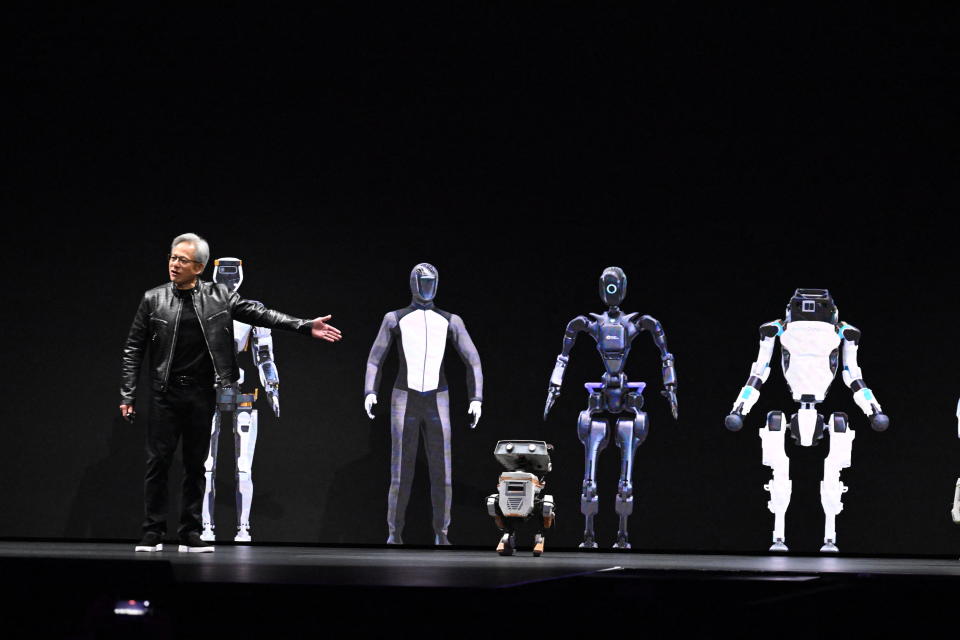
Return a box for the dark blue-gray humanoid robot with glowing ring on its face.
[543,267,677,549]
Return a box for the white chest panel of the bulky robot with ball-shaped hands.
[780,320,840,402]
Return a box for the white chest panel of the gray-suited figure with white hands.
[400,309,449,393]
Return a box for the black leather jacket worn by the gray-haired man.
[120,279,312,405]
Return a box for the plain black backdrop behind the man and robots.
[7,3,960,554]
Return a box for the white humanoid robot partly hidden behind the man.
[200,258,280,542]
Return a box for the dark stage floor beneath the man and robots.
[0,542,960,637]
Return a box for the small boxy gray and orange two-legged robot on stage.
[487,440,555,556]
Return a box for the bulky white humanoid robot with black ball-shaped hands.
[724,289,890,552]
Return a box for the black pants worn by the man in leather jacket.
[143,384,217,538]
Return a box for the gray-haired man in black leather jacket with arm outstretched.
[120,233,341,552]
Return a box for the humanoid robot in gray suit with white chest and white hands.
[363,262,483,545]
